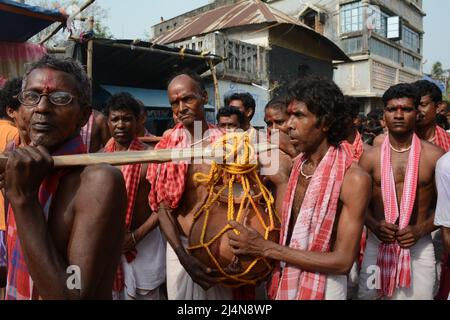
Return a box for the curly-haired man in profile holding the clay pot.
[229,77,371,300]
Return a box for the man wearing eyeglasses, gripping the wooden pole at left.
[0,56,126,300]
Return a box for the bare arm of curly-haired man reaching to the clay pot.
[228,168,371,274]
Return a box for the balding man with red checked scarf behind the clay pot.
[147,72,227,300]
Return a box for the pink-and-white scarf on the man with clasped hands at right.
[377,134,422,297]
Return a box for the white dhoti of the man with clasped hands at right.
[358,232,436,300]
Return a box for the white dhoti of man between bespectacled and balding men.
[120,228,166,300]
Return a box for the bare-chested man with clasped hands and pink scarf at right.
[358,84,443,300]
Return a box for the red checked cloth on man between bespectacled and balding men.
[104,138,146,292]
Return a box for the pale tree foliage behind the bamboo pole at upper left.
[27,0,114,46]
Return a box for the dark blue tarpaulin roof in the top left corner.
[0,0,66,42]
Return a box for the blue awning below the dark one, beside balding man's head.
[101,85,214,109]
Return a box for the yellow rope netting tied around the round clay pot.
[188,132,280,287]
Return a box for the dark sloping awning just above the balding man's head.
[73,39,222,90]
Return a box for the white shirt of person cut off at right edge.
[434,152,450,228]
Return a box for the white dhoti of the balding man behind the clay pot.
[166,237,233,300]
